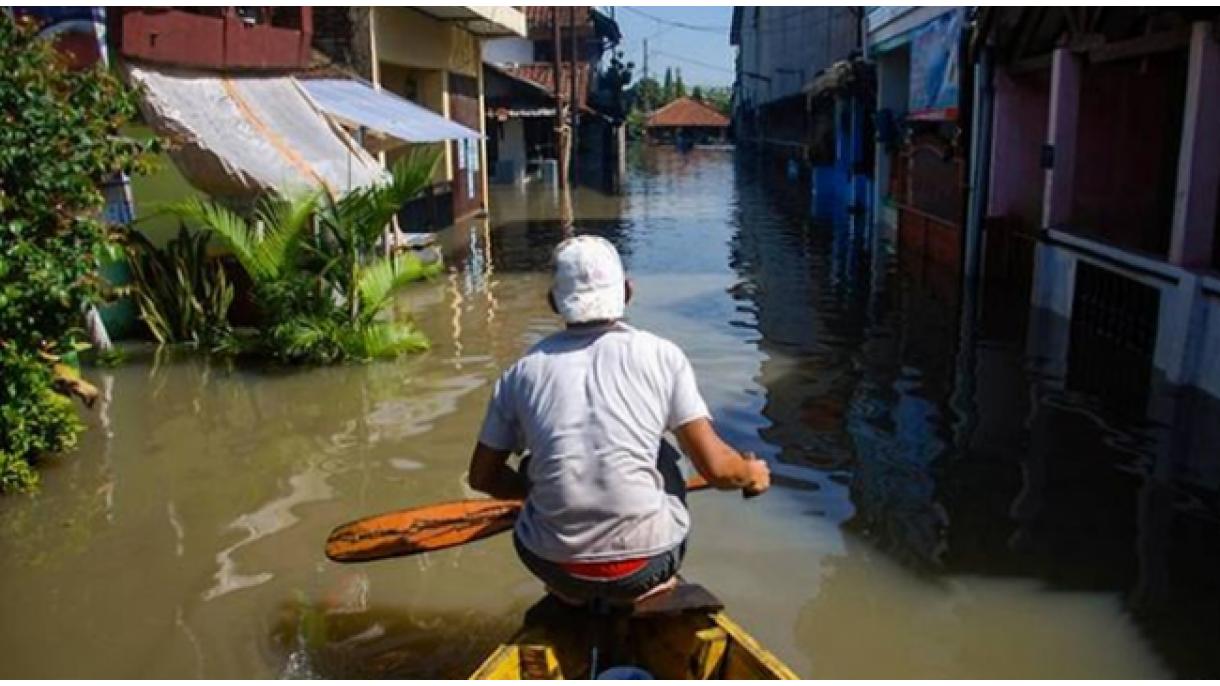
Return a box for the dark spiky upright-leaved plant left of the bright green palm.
[127,226,233,348]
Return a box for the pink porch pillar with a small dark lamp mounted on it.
[1042,48,1081,227]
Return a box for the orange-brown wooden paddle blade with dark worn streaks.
[326,499,521,563]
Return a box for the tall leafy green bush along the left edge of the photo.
[0,11,156,491]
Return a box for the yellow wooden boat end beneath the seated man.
[471,582,798,680]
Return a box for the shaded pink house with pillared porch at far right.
[965,7,1220,397]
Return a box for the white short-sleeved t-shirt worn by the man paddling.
[479,322,710,563]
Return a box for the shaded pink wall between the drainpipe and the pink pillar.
[987,70,1050,231]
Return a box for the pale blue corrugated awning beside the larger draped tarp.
[299,78,483,143]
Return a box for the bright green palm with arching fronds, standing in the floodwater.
[171,151,440,364]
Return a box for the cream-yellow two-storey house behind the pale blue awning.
[314,6,526,229]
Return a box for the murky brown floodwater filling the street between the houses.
[0,150,1220,677]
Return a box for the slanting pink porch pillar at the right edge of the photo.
[1169,22,1220,267]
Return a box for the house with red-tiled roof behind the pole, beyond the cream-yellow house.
[483,6,625,189]
